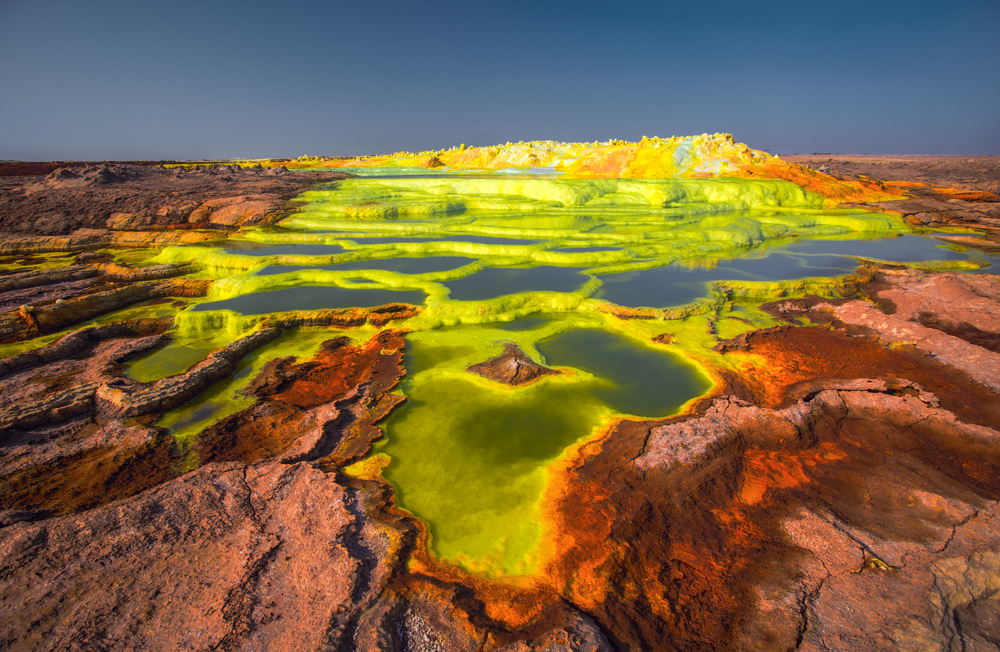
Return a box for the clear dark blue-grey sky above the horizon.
[0,0,1000,160]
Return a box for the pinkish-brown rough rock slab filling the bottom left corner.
[0,462,397,650]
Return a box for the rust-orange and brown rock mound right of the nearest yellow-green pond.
[549,380,1000,650]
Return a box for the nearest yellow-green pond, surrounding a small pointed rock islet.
[380,320,708,575]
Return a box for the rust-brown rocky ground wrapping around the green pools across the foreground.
[0,159,1000,652]
